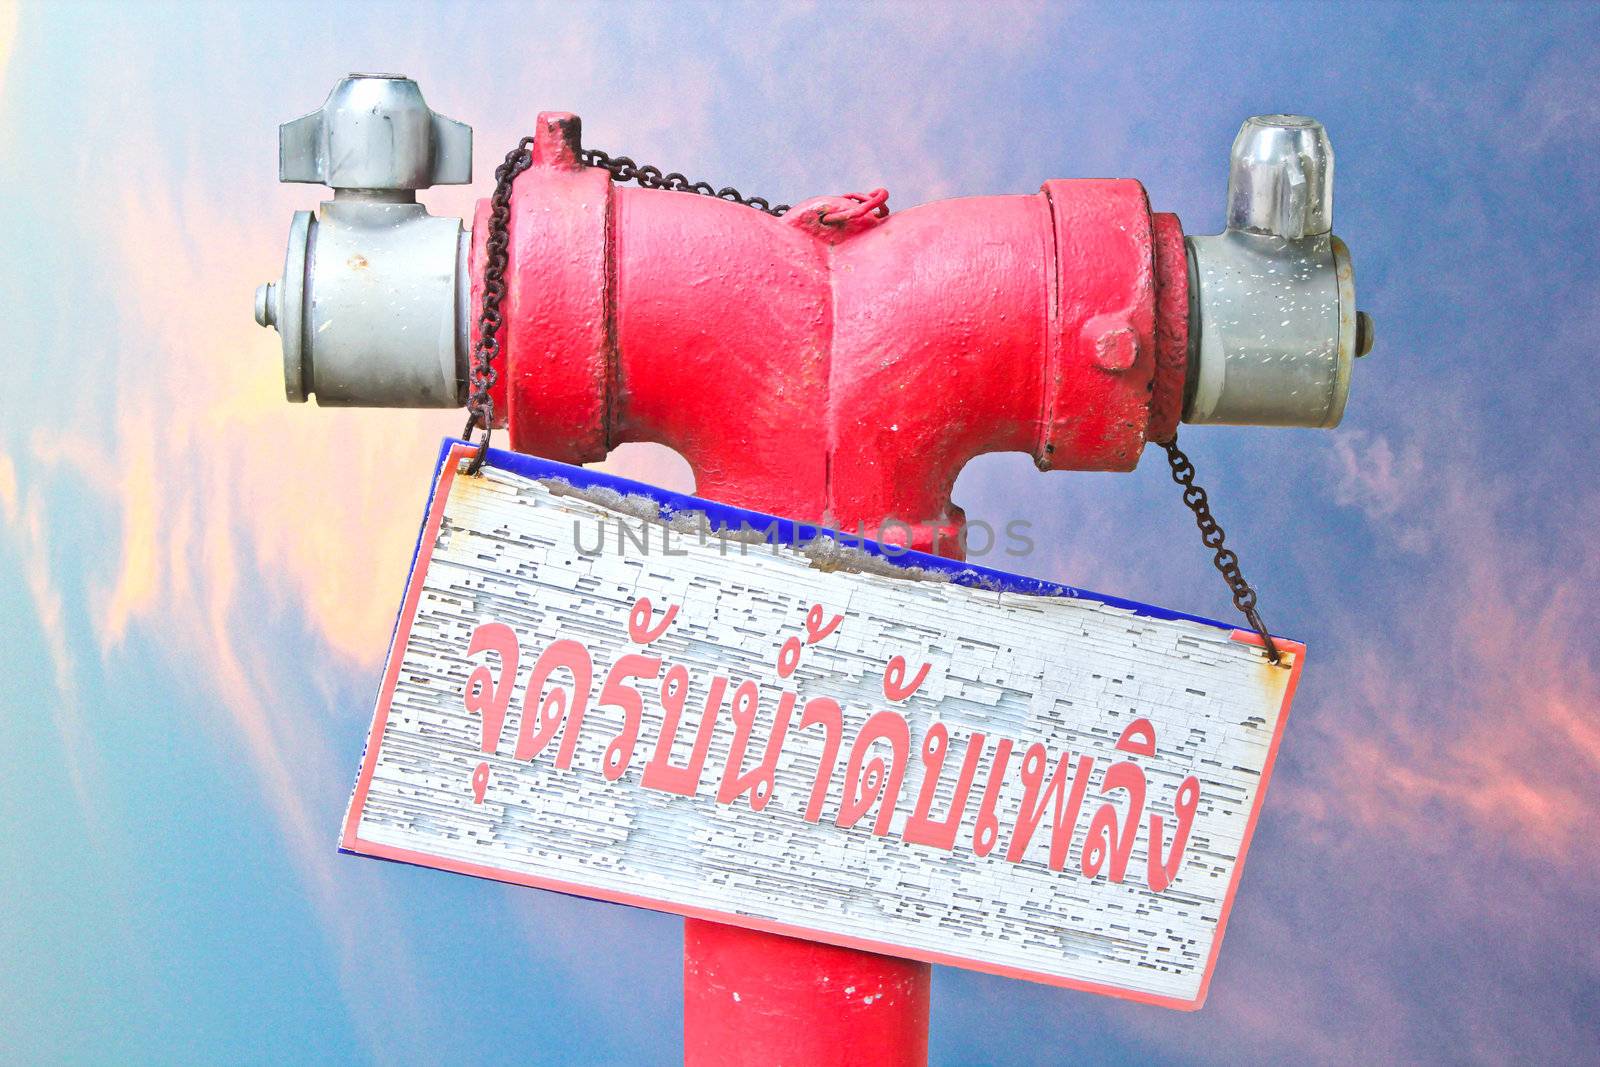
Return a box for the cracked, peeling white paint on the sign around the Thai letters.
[346,469,1288,1003]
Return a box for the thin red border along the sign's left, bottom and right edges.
[339,445,1306,1011]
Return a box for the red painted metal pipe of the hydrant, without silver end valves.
[474,114,1189,1067]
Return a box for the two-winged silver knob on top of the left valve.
[278,74,472,190]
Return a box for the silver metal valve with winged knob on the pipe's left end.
[256,74,472,408]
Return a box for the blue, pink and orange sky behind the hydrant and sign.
[0,2,1600,1064]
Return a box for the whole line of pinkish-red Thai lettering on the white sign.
[461,597,1200,893]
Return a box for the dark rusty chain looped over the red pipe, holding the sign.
[461,138,1283,664]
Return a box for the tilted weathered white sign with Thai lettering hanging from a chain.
[341,443,1304,1008]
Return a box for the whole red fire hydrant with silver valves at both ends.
[256,75,1371,1064]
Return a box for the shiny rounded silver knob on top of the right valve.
[1227,115,1333,240]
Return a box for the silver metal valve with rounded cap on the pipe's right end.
[1184,115,1373,427]
